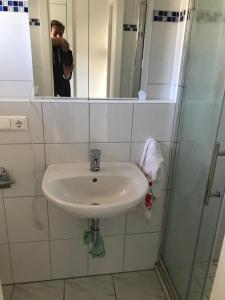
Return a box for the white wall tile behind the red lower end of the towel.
[126,192,165,234]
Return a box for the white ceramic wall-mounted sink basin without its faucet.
[42,162,148,218]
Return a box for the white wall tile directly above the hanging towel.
[132,103,175,142]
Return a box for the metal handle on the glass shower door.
[204,143,225,205]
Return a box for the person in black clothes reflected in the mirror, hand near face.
[51,20,74,97]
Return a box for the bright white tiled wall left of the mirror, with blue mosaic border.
[0,1,33,98]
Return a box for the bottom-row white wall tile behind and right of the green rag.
[88,235,124,275]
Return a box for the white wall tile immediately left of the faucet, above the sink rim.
[45,143,89,165]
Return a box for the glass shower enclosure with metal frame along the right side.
[159,0,225,300]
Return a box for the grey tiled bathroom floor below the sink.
[3,271,166,300]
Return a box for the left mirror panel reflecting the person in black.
[29,0,88,98]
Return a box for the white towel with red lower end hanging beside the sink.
[139,138,164,220]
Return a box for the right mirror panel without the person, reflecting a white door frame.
[89,0,149,98]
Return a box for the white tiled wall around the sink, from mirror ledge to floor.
[0,99,175,284]
